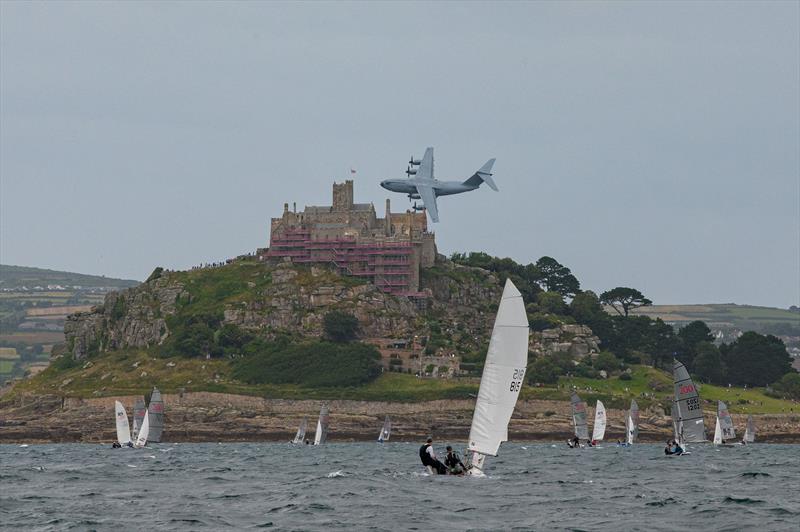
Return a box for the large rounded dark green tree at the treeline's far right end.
[721,331,792,386]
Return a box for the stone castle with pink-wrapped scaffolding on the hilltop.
[262,180,436,298]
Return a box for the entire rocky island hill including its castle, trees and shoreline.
[0,181,800,441]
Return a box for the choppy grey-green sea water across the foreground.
[0,442,800,531]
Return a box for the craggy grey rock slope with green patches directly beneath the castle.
[64,259,501,359]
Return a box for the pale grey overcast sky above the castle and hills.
[0,0,800,307]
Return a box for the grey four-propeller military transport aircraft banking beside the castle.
[381,148,498,222]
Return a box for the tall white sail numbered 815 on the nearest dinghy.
[468,279,528,476]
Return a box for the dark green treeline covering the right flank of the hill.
[451,253,800,395]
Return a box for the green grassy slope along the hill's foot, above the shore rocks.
[12,351,797,414]
